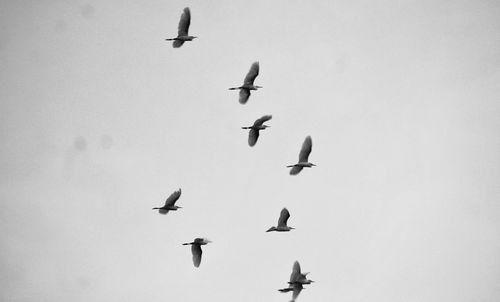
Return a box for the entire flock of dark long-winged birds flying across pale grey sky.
[158,7,315,301]
